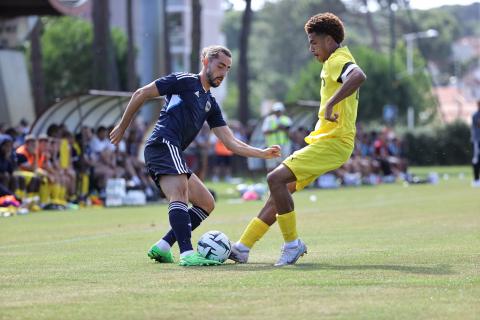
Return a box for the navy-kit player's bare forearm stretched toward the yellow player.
[212,125,280,159]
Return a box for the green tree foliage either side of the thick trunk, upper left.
[41,17,127,105]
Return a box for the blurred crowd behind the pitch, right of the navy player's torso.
[186,102,408,186]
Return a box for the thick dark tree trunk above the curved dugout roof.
[92,0,119,90]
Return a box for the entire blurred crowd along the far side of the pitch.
[0,103,407,211]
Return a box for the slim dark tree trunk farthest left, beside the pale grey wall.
[30,18,47,117]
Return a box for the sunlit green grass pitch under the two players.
[0,168,480,319]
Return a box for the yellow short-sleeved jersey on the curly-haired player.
[305,47,358,146]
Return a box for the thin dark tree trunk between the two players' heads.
[238,0,252,125]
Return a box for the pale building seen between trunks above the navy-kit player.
[101,0,227,103]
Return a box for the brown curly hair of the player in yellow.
[305,12,345,43]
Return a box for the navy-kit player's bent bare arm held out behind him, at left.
[110,81,160,145]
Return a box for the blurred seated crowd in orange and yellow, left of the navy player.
[0,117,156,211]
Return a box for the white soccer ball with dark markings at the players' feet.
[197,231,232,262]
